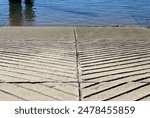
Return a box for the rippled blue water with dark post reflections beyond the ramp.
[0,0,150,26]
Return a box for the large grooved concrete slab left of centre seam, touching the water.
[0,27,77,82]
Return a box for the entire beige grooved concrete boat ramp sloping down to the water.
[0,27,150,101]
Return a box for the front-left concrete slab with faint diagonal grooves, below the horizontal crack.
[0,83,78,101]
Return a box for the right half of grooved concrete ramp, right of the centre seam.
[76,27,150,100]
